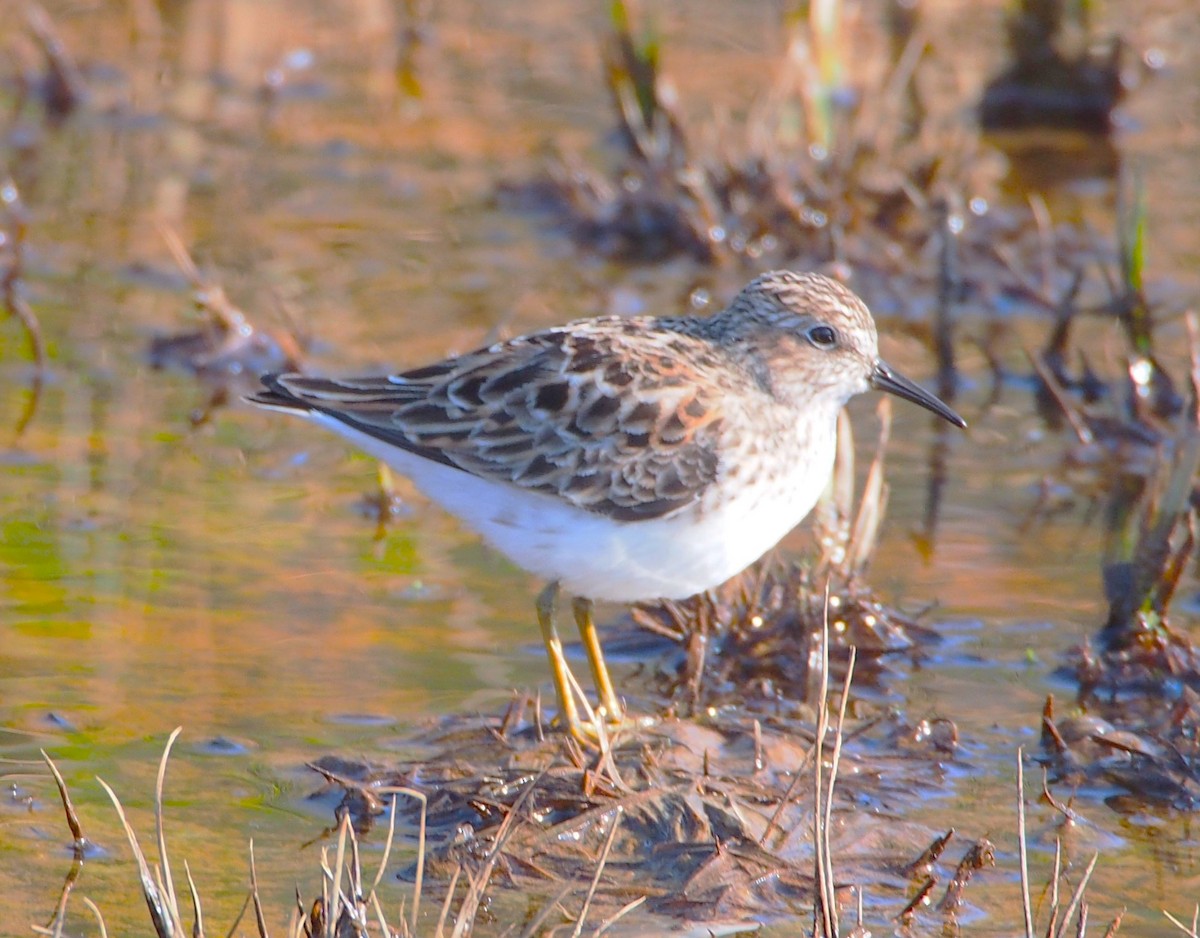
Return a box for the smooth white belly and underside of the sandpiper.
[308,413,834,602]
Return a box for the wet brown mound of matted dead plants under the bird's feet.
[304,705,960,920]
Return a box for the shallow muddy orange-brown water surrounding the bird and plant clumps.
[0,0,1200,934]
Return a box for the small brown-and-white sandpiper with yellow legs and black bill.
[250,271,966,741]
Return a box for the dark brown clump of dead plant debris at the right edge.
[1042,331,1200,811]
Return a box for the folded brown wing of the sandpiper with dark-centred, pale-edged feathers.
[257,320,720,521]
